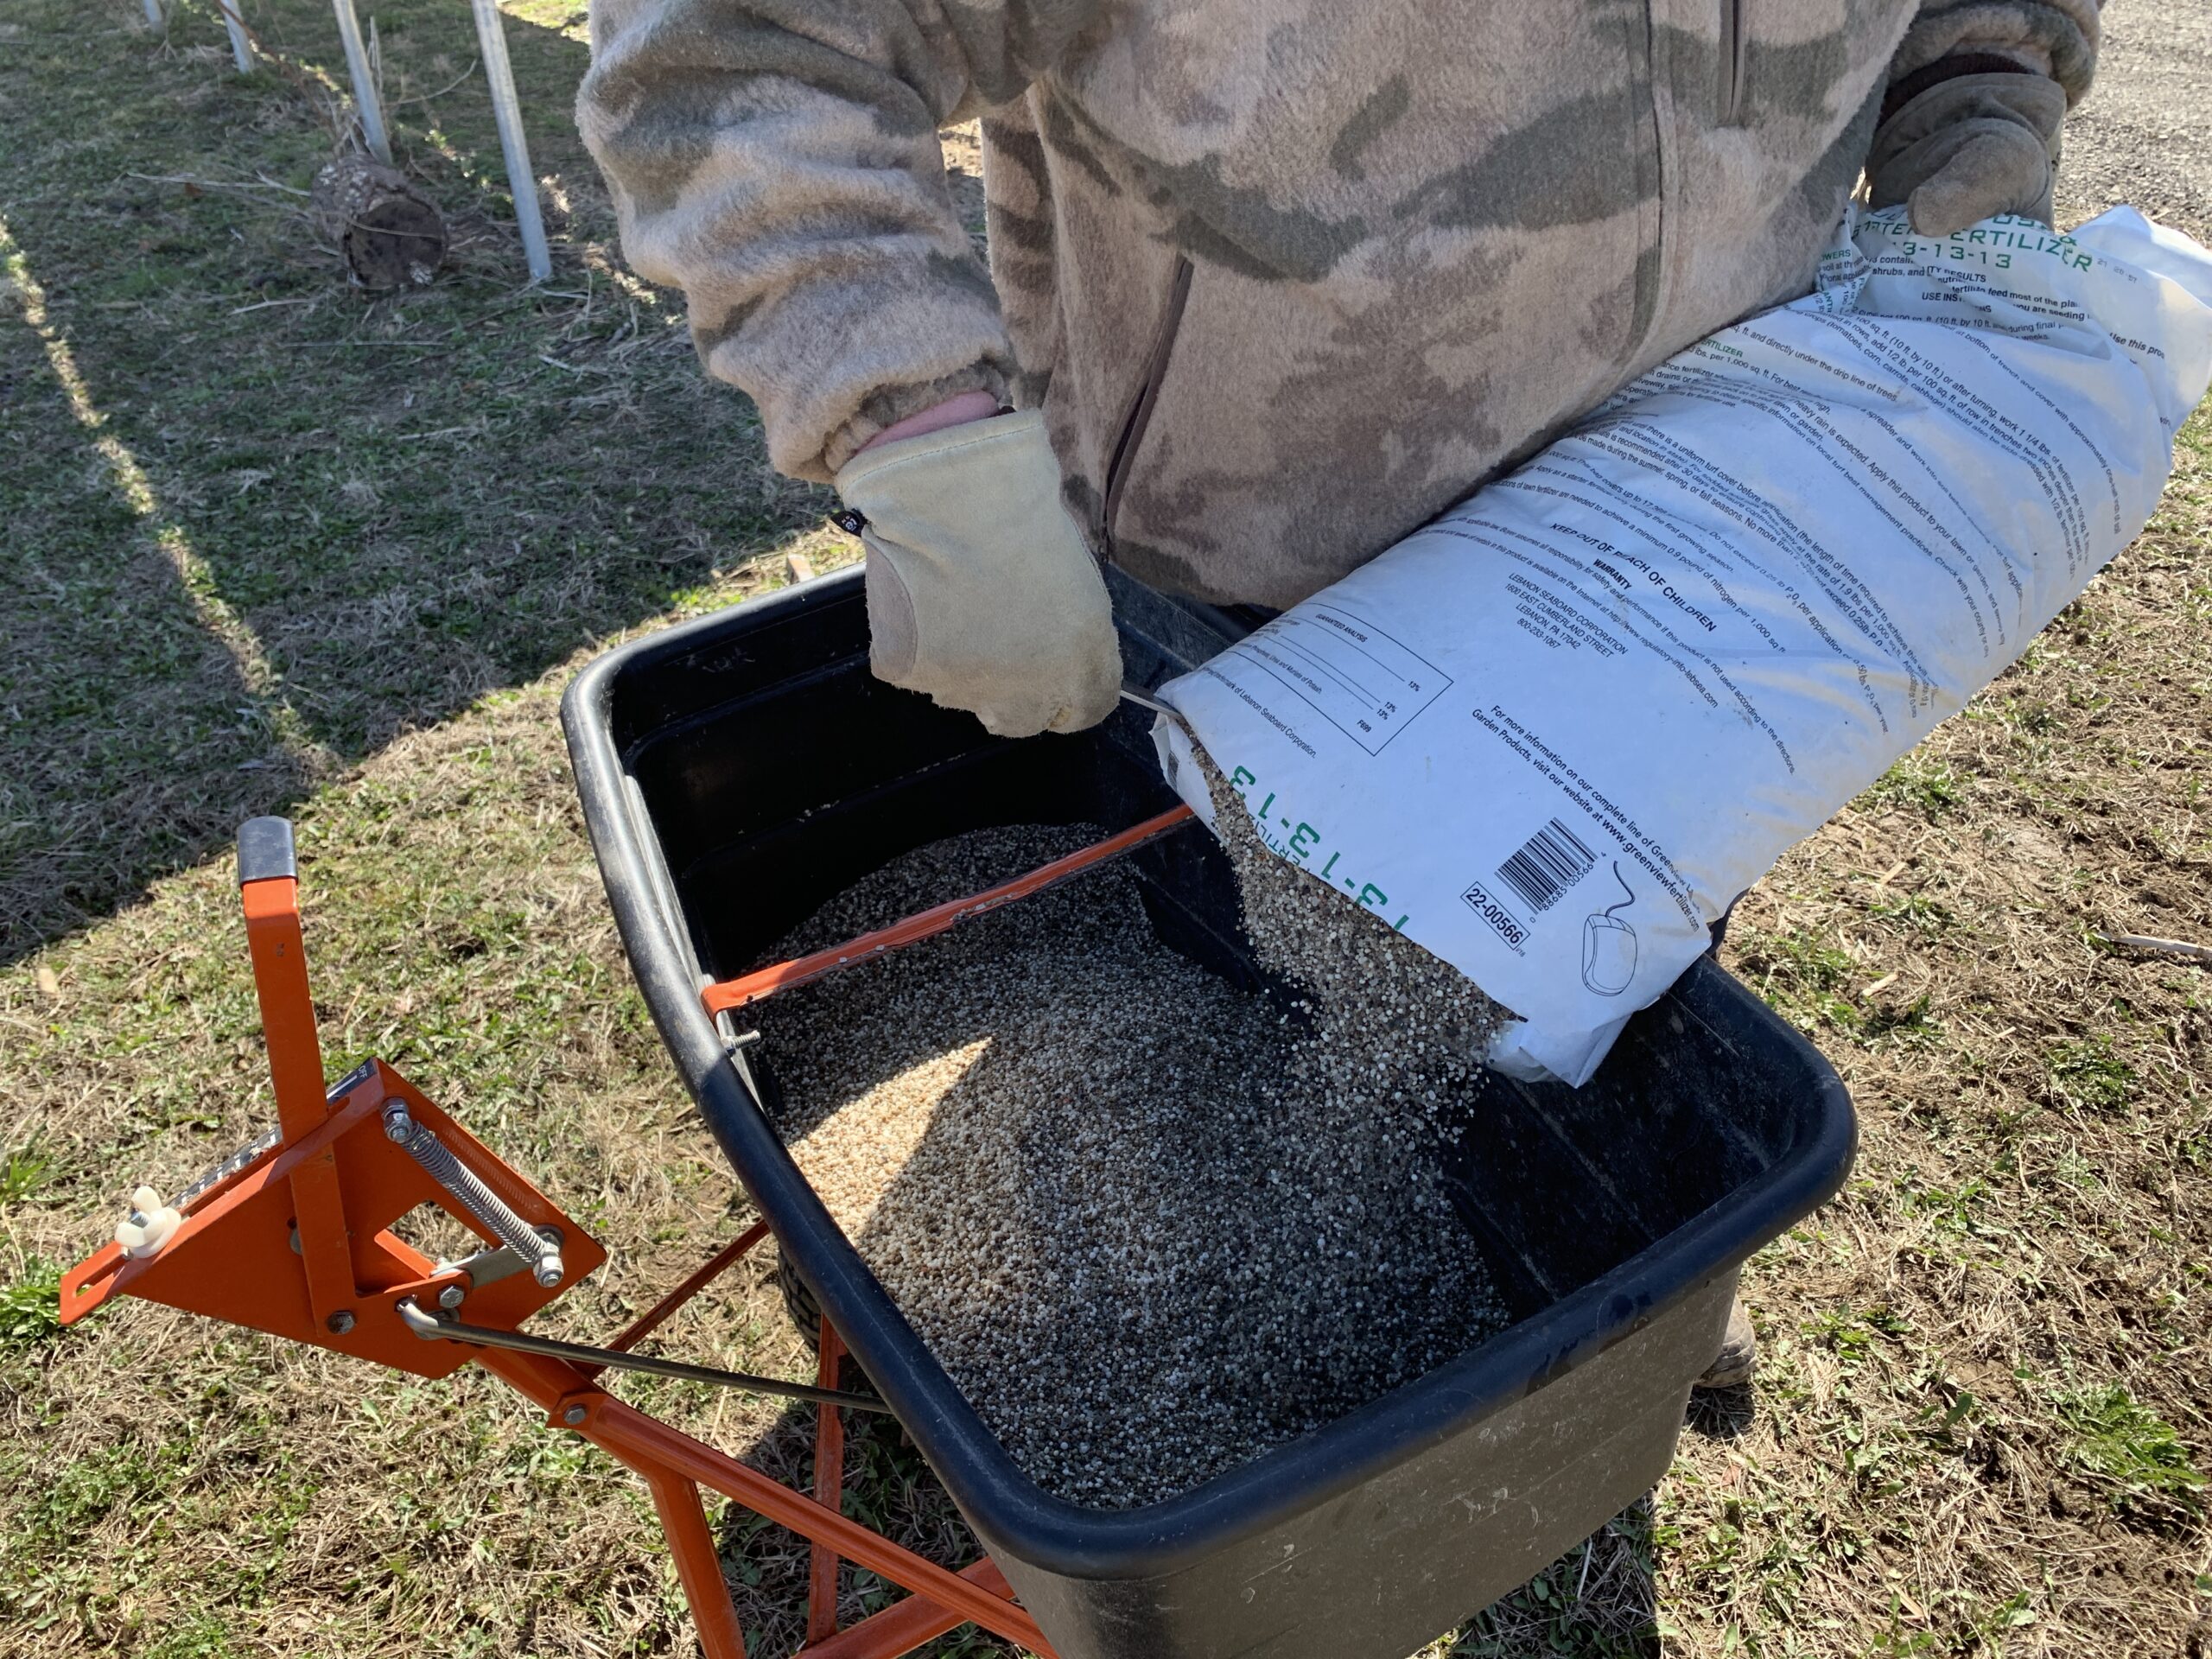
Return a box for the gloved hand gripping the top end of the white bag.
[1867,73,2066,237]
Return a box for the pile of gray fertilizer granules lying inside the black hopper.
[761,827,1504,1509]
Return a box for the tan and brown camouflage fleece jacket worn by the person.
[580,0,2097,606]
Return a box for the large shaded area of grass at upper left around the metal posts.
[0,0,862,963]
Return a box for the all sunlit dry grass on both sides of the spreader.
[0,444,2212,1656]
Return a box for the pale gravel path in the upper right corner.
[2057,0,2212,244]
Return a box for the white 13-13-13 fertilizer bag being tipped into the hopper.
[1157,208,2212,1084]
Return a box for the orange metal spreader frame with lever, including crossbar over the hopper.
[62,831,1071,1659]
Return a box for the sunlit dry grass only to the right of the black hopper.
[1659,414,2212,1659]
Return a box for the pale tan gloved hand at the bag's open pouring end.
[836,411,1122,736]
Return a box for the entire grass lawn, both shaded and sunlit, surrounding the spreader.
[0,0,2212,1659]
